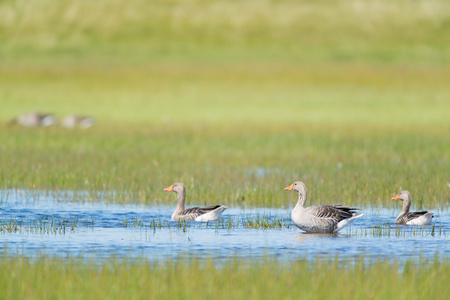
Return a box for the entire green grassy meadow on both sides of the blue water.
[0,0,450,299]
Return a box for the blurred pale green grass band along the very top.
[0,0,450,65]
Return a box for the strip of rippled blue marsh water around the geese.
[0,190,450,261]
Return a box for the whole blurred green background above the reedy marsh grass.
[0,0,450,125]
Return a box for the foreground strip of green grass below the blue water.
[0,257,450,300]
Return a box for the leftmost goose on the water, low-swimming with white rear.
[164,182,227,222]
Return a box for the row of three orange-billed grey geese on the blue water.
[164,181,433,233]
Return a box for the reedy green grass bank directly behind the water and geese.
[0,124,450,209]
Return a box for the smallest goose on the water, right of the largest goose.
[392,191,433,225]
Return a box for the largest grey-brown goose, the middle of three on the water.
[285,181,363,233]
